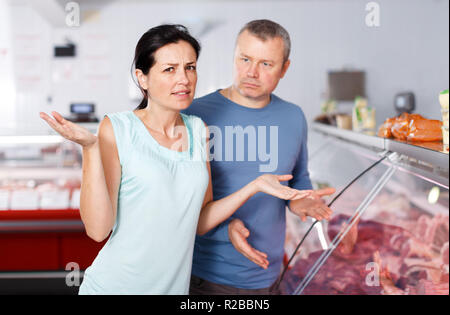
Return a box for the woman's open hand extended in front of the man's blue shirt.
[254,174,313,200]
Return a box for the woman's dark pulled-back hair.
[133,24,201,109]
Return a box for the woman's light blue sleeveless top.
[79,111,209,294]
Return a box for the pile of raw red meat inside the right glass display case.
[282,215,449,295]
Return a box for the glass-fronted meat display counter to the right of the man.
[280,124,449,295]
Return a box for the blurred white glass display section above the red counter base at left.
[0,136,82,211]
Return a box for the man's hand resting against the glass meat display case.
[289,188,336,221]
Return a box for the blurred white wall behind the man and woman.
[4,0,449,134]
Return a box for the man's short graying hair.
[239,20,291,62]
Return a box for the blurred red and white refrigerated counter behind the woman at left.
[0,136,103,294]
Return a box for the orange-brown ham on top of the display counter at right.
[378,113,442,142]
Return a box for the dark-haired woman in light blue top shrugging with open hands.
[41,25,309,294]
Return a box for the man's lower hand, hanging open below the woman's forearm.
[228,219,269,269]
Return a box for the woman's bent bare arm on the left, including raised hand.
[41,112,121,242]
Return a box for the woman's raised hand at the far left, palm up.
[39,112,97,148]
